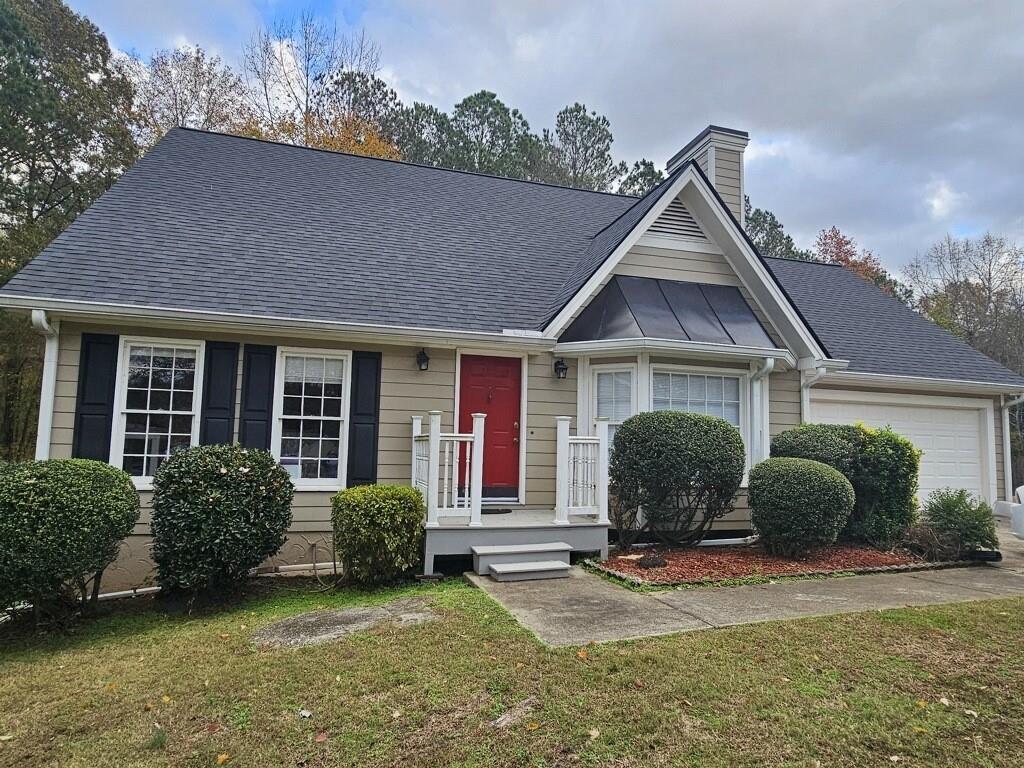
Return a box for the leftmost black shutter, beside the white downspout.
[71,334,118,462]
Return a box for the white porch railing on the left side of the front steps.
[412,411,485,527]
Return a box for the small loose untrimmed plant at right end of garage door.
[904,488,999,560]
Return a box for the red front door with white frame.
[459,354,522,499]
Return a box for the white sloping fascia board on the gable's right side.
[683,174,828,361]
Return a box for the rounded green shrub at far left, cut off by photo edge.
[0,459,139,616]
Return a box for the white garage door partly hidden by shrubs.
[811,390,987,502]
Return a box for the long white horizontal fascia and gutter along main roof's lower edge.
[0,295,554,351]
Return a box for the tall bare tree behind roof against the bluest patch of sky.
[243,10,380,145]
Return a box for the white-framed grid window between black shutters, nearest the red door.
[273,350,349,487]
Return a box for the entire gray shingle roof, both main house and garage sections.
[0,129,1024,388]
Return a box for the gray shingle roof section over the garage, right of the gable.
[765,258,1024,388]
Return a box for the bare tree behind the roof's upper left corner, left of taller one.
[124,46,248,146]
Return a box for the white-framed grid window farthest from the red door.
[111,339,203,484]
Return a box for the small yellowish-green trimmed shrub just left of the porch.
[331,485,426,585]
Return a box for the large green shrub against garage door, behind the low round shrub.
[771,424,921,549]
